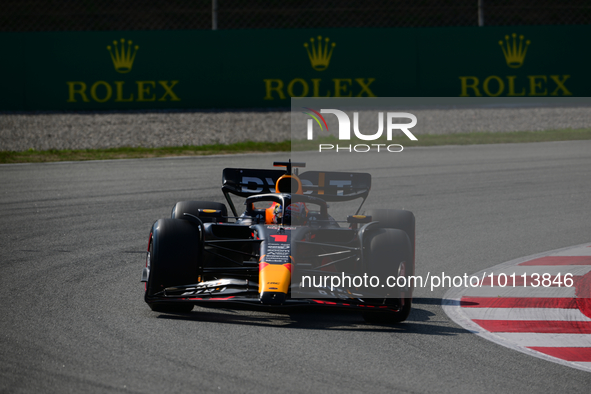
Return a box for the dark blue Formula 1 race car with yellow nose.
[142,160,415,323]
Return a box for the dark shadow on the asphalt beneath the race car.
[158,298,469,335]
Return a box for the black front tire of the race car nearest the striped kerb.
[363,228,413,324]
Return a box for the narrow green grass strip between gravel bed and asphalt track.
[0,129,591,163]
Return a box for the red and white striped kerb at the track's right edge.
[443,243,591,372]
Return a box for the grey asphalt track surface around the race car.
[0,141,591,393]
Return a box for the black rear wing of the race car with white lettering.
[222,168,371,216]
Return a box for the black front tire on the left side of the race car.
[145,219,202,312]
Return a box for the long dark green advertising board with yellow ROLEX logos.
[0,26,591,111]
